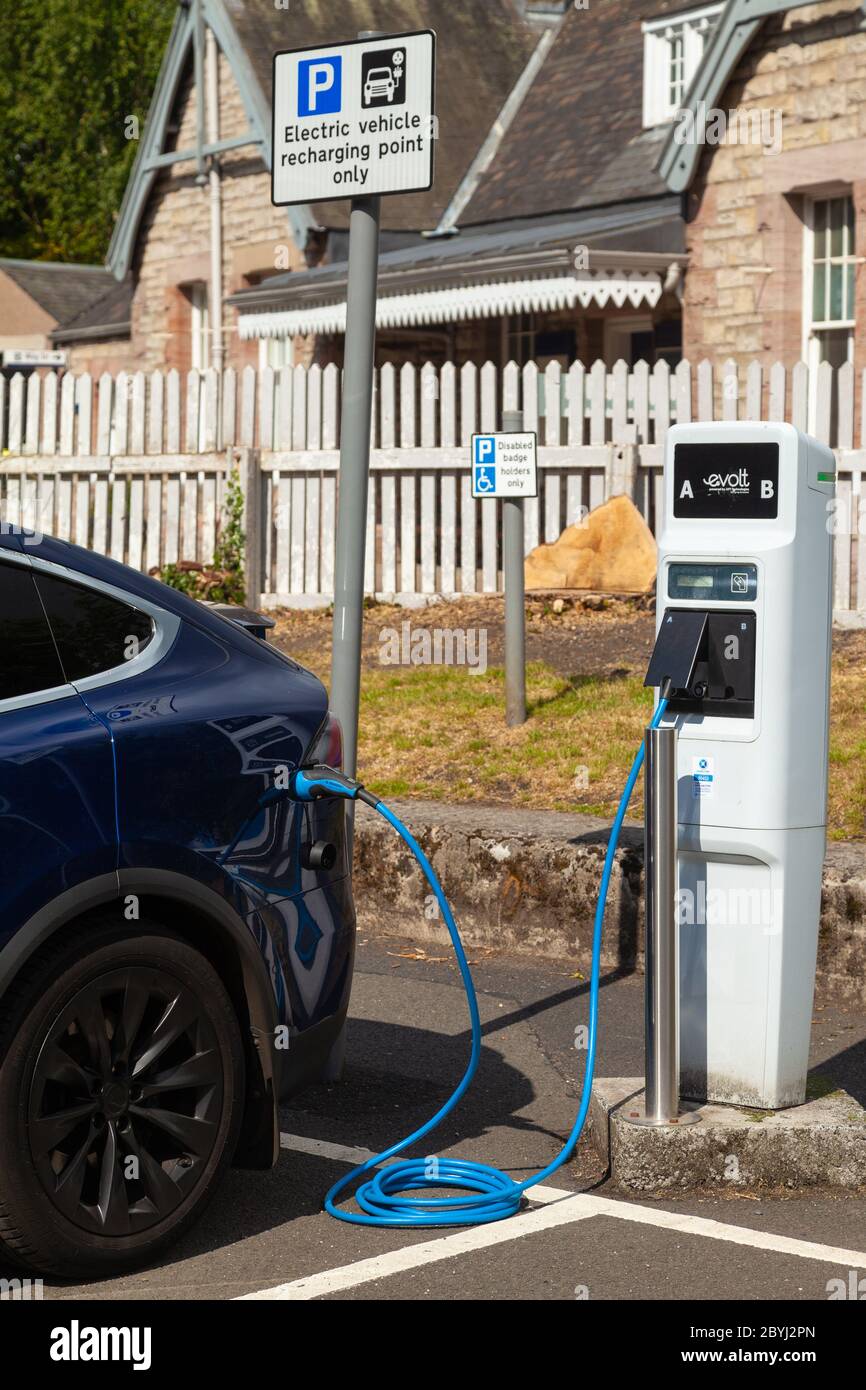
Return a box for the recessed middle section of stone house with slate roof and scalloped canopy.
[231,0,695,366]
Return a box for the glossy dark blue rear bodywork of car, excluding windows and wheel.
[0,532,354,1147]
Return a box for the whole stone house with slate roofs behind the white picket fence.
[44,0,866,386]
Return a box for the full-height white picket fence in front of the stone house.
[0,361,866,620]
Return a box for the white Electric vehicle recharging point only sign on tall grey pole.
[271,29,436,206]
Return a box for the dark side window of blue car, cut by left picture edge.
[0,562,65,699]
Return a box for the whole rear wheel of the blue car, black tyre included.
[0,919,245,1279]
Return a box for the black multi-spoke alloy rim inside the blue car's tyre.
[28,966,224,1236]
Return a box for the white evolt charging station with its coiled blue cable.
[289,423,835,1227]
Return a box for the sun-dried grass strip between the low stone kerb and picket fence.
[278,598,866,840]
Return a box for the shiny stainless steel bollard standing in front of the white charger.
[644,728,680,1125]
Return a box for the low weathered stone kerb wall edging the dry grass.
[354,801,866,1006]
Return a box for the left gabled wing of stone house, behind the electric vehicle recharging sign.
[54,0,537,371]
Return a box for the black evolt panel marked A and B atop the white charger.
[674,443,778,521]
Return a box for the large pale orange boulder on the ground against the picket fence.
[525,496,657,594]
